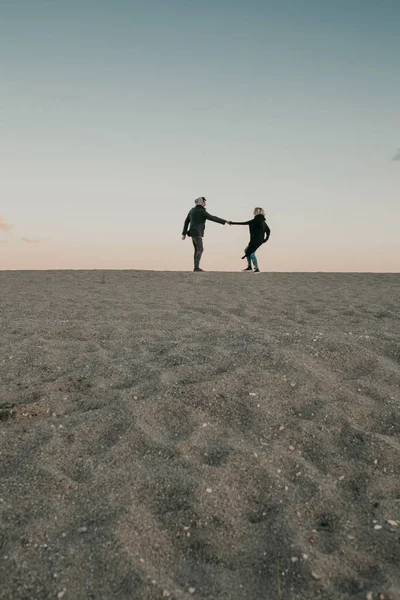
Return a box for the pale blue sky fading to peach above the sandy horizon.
[0,0,400,272]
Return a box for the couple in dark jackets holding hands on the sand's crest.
[182,196,271,273]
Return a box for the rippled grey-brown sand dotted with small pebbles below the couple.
[0,271,400,600]
